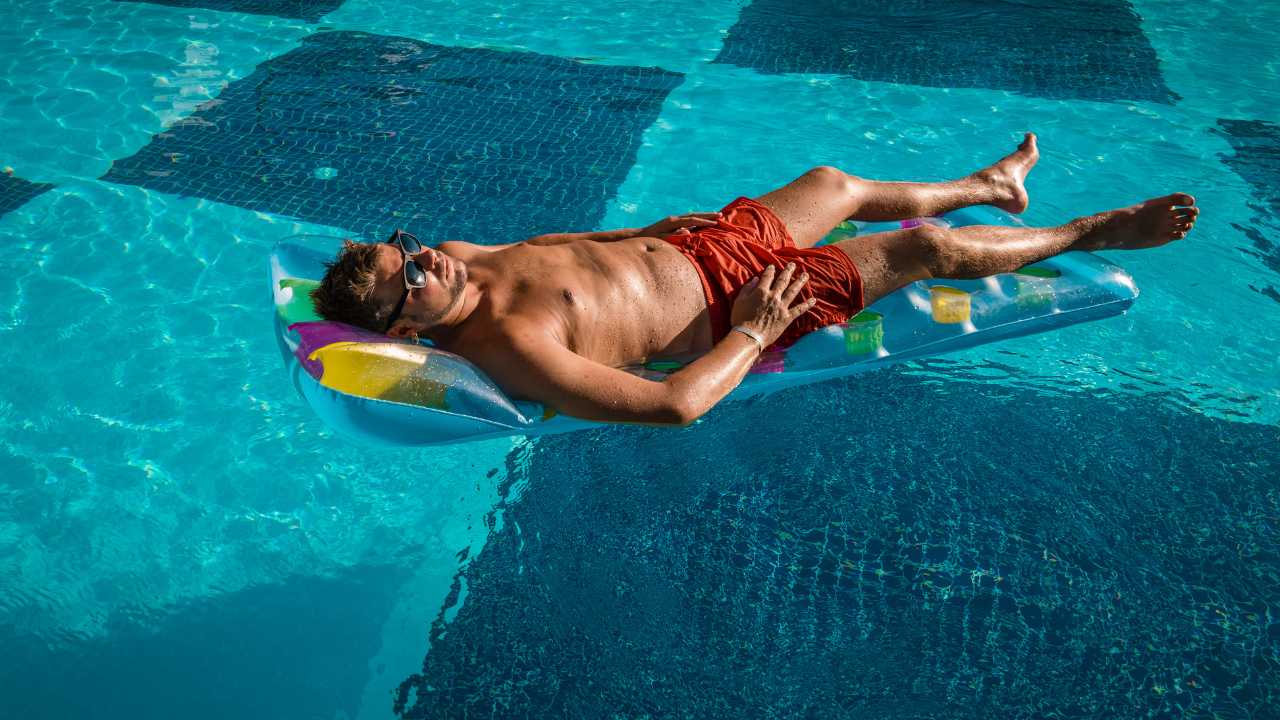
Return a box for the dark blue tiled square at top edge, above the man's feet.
[716,0,1178,104]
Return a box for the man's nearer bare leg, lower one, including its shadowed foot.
[833,192,1199,305]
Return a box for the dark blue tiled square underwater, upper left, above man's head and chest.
[104,32,682,242]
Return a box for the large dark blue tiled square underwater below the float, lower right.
[397,369,1280,719]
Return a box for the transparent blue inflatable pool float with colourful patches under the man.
[271,208,1138,446]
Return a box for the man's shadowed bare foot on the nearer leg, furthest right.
[1075,192,1199,250]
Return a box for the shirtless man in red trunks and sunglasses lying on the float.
[312,133,1199,425]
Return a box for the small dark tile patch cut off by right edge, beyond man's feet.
[1216,119,1280,302]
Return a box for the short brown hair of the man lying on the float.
[311,240,390,332]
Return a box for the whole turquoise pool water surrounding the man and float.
[0,0,1280,719]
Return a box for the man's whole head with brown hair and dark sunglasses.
[311,234,467,337]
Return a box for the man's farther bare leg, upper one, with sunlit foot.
[756,133,1039,247]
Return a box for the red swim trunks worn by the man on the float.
[663,197,863,348]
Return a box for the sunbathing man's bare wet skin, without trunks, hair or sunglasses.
[372,133,1198,425]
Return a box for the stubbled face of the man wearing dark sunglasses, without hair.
[374,238,467,337]
